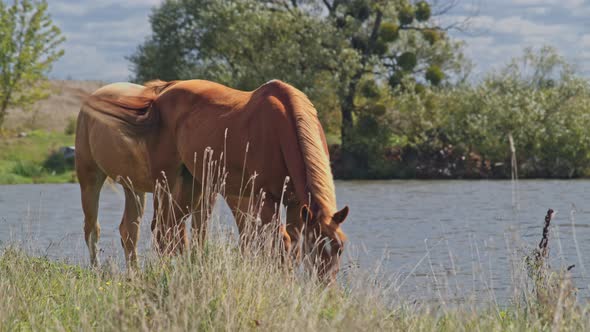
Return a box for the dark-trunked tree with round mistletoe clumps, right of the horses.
[306,0,464,177]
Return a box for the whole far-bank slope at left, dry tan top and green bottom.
[0,80,99,184]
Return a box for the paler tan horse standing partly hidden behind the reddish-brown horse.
[76,83,169,265]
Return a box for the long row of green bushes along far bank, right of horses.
[334,48,590,178]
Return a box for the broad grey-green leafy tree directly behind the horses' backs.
[129,0,357,130]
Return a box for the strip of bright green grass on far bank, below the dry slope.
[0,130,75,184]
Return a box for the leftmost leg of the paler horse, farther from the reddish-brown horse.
[77,168,106,266]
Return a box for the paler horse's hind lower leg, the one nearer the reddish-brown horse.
[119,188,145,269]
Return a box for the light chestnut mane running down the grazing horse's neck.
[267,81,336,213]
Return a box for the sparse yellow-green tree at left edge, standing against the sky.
[0,0,65,127]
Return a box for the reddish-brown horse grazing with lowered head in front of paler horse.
[79,80,348,278]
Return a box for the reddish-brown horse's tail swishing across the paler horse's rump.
[83,80,179,135]
